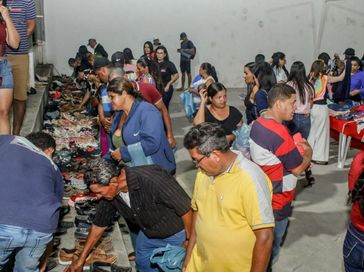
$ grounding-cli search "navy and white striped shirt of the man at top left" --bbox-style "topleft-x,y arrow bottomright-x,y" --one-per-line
7,0 -> 36,55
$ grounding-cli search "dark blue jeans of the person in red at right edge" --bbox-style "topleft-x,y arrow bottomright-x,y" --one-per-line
343,223 -> 364,272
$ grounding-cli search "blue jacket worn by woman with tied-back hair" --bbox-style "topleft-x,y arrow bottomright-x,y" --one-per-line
111,100 -> 176,172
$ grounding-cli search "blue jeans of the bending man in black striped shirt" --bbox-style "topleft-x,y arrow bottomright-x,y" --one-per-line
135,230 -> 186,272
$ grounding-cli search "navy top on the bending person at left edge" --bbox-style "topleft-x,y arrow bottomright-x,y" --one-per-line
0,135 -> 63,233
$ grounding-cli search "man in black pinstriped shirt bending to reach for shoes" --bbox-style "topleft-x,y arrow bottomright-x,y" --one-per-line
66,165 -> 192,272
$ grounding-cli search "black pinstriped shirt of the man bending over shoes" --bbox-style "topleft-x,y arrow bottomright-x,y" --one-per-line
93,165 -> 191,239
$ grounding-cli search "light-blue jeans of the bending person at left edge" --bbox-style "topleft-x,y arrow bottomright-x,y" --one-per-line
0,224 -> 52,272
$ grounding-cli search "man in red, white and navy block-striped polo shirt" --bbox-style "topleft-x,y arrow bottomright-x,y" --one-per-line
250,84 -> 312,270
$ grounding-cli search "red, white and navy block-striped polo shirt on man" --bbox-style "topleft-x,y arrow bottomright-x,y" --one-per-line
250,115 -> 303,221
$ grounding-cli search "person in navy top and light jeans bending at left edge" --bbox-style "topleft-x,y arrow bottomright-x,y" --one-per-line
0,132 -> 63,272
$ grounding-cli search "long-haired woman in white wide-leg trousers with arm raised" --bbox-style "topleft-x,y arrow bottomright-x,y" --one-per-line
308,60 -> 345,165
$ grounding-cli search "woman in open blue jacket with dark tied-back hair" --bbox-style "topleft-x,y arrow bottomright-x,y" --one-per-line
108,78 -> 176,174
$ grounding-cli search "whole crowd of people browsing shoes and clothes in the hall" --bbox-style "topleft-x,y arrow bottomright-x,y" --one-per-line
0,0 -> 364,272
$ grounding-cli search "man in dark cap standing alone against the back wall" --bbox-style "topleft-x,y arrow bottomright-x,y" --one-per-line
177,32 -> 196,90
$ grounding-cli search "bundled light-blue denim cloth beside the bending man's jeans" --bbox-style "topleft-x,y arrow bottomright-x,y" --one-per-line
150,244 -> 186,272
